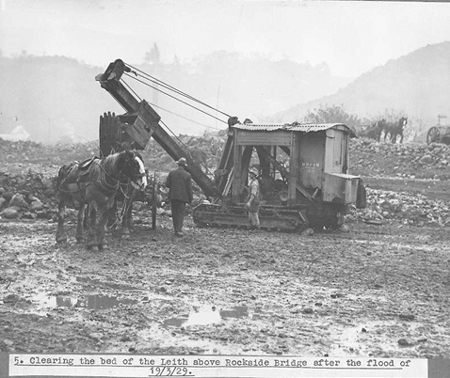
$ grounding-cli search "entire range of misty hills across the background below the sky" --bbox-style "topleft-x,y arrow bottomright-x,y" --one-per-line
5,42 -> 450,143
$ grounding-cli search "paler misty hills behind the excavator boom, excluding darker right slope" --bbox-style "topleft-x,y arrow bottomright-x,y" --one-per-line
0,52 -> 349,143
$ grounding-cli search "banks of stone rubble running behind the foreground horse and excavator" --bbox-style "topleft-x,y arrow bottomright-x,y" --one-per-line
0,136 -> 450,226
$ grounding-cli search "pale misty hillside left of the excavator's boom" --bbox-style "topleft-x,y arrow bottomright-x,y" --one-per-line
0,56 -> 121,142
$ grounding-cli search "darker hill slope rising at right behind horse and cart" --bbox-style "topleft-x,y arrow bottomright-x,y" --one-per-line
273,42 -> 450,140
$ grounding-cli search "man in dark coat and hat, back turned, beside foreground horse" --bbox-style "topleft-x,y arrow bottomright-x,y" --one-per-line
166,158 -> 192,237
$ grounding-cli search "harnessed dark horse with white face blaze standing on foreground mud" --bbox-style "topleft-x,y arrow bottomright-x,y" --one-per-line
56,150 -> 147,250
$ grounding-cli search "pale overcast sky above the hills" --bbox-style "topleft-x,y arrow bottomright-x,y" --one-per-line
0,0 -> 450,77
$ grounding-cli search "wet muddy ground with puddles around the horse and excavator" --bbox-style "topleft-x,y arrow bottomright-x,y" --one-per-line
0,140 -> 450,358
